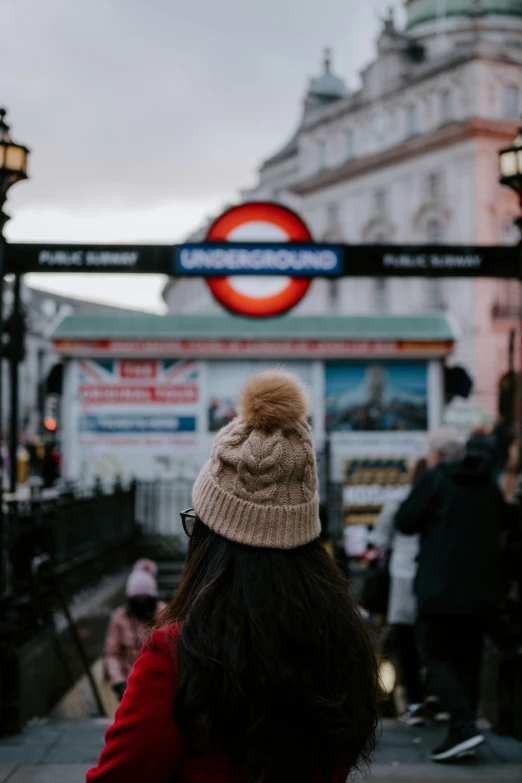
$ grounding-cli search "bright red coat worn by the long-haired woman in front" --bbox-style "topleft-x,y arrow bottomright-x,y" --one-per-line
87,626 -> 349,783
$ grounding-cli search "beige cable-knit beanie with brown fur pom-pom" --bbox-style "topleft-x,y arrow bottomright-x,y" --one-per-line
192,370 -> 321,549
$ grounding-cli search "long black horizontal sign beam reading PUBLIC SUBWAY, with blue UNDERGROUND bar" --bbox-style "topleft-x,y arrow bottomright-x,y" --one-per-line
5,242 -> 522,279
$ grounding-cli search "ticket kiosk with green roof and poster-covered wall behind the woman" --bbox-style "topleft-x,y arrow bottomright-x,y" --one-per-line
53,313 -> 455,544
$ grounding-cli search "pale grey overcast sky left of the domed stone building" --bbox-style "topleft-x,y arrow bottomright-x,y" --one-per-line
0,0 -> 402,309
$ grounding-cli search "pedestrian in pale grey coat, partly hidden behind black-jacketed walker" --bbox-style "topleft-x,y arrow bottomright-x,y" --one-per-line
373,458 -> 428,726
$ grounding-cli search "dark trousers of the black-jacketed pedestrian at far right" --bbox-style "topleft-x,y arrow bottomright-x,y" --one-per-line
418,614 -> 484,732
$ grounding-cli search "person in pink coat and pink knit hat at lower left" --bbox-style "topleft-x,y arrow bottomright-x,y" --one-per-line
104,560 -> 166,699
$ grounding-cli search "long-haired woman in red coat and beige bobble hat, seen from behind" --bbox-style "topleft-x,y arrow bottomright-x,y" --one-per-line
87,371 -> 378,783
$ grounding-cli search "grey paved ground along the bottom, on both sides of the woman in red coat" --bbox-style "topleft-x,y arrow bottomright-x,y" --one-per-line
0,718 -> 522,783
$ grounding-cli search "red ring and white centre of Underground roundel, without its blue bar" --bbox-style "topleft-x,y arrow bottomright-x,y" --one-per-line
206,202 -> 313,318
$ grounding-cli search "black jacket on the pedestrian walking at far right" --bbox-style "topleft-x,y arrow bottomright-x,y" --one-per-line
395,453 -> 510,615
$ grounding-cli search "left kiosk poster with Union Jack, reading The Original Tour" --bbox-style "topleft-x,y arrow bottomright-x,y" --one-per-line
70,359 -> 201,481
